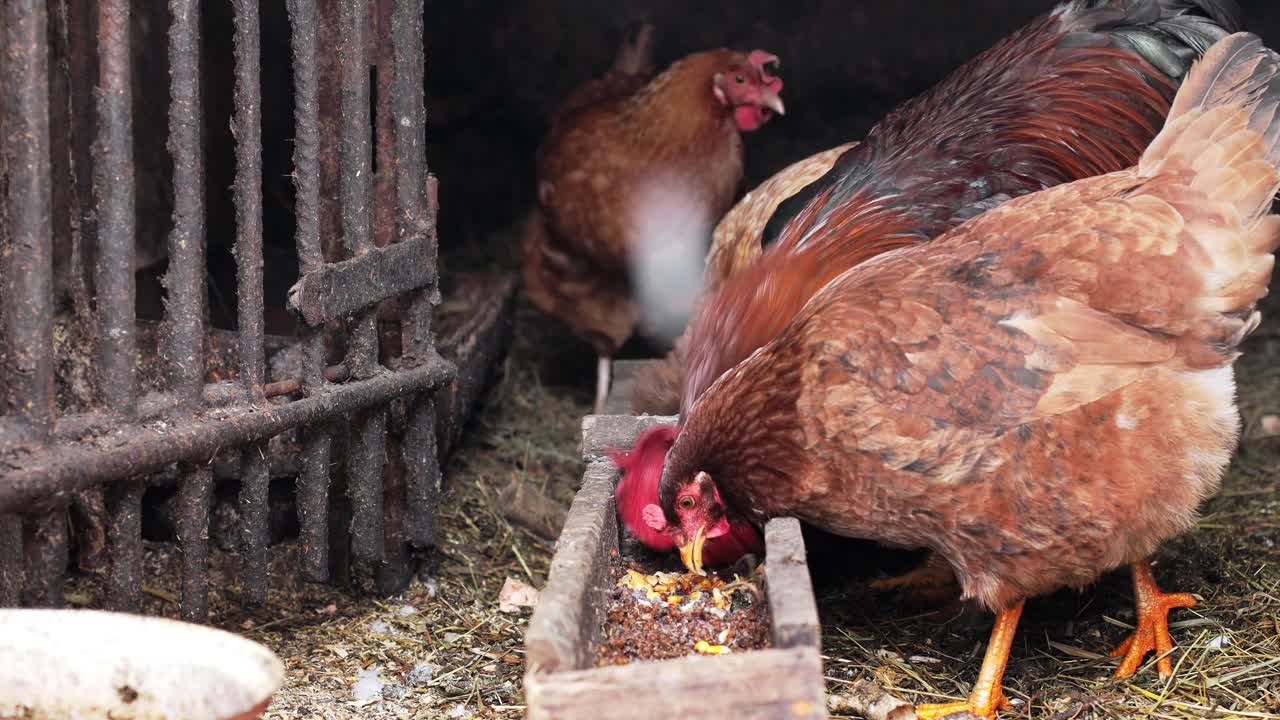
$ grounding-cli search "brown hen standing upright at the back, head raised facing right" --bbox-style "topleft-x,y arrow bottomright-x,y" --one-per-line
521,25 -> 783,413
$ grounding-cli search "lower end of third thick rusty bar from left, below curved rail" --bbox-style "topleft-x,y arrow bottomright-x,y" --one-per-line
178,462 -> 214,623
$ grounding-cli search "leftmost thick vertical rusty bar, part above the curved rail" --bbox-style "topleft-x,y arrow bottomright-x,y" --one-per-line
0,0 -> 55,441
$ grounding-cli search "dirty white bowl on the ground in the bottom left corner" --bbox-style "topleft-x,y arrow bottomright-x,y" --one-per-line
0,610 -> 284,720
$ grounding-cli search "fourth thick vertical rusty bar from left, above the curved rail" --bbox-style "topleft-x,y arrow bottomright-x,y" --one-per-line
232,0 -> 265,400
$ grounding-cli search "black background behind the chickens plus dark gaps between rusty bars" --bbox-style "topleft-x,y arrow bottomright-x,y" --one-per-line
115,0 -> 1280,334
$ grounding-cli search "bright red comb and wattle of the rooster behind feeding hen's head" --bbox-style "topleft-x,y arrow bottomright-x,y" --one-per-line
609,425 -> 764,566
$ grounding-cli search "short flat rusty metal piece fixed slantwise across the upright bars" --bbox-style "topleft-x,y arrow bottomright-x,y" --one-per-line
289,237 -> 435,325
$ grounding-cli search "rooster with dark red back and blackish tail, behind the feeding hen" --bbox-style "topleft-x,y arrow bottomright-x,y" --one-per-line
614,0 -> 1239,571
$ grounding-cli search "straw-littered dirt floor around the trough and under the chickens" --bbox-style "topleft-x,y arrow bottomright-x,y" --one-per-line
60,280 -> 1280,720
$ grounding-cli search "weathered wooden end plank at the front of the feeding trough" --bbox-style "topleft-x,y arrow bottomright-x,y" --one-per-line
525,648 -> 827,720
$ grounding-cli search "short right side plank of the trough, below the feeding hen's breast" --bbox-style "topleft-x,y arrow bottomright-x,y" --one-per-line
764,518 -> 822,650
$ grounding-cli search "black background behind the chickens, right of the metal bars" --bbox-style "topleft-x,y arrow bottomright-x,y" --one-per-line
426,0 -> 1280,256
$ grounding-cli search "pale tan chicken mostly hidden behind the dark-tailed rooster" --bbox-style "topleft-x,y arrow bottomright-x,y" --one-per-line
631,142 -> 858,415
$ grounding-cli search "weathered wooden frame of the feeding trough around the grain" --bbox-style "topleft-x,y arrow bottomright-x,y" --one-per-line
525,373 -> 827,720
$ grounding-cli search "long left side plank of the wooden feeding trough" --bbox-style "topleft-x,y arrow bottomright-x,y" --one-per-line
525,462 -> 618,673
